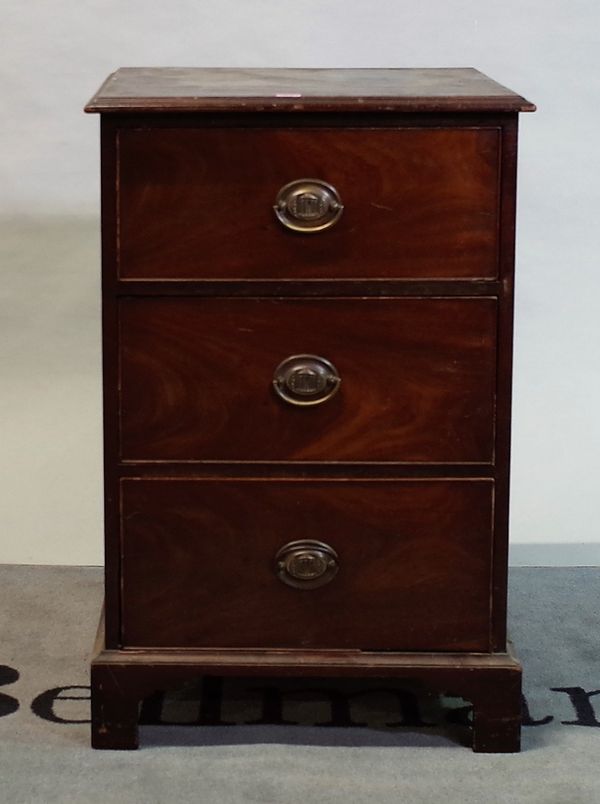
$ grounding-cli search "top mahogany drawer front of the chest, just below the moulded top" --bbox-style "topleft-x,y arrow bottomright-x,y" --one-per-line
118,127 -> 500,279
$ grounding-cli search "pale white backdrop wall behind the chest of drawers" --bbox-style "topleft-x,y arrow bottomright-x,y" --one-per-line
0,0 -> 600,564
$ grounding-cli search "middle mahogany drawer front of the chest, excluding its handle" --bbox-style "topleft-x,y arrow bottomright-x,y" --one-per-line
119,298 -> 496,463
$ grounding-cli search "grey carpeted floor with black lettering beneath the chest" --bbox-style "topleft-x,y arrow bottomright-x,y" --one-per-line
0,566 -> 600,804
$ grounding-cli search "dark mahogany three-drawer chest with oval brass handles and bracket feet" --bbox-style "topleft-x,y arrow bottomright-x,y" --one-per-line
86,69 -> 533,751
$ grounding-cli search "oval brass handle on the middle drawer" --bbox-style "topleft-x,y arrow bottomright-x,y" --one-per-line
273,355 -> 342,406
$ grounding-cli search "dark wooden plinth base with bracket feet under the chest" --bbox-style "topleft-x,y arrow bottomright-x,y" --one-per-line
91,612 -> 521,753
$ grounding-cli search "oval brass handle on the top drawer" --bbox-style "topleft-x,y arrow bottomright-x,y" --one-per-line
273,179 -> 344,233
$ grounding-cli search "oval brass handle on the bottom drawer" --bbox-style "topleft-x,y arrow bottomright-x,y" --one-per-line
275,539 -> 339,589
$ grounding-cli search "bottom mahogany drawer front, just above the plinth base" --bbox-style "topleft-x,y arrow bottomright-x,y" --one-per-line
121,479 -> 493,651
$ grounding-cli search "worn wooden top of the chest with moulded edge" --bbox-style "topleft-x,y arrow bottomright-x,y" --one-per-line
85,67 -> 535,112
